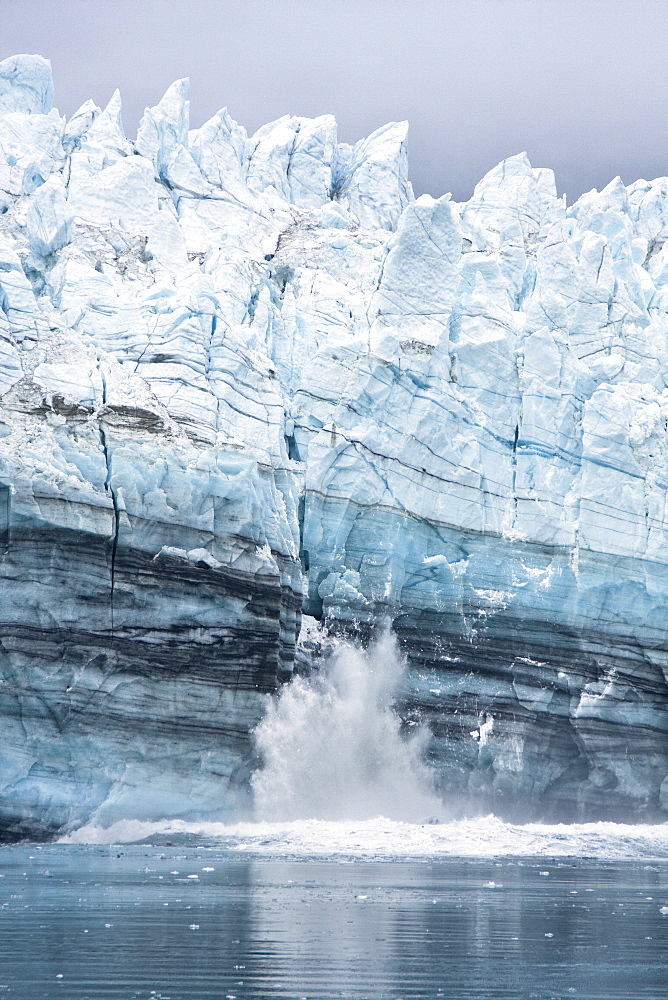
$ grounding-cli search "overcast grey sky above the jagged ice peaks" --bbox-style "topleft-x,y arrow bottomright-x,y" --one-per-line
0,0 -> 668,200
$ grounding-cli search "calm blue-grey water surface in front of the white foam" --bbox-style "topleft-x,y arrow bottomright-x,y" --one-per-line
0,843 -> 668,1000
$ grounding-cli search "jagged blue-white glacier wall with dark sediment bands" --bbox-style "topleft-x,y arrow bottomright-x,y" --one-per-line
0,55 -> 668,840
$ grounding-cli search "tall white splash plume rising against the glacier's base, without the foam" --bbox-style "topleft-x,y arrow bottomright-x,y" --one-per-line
252,632 -> 442,821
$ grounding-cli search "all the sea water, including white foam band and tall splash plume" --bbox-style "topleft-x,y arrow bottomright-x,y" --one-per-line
0,636 -> 668,1000
